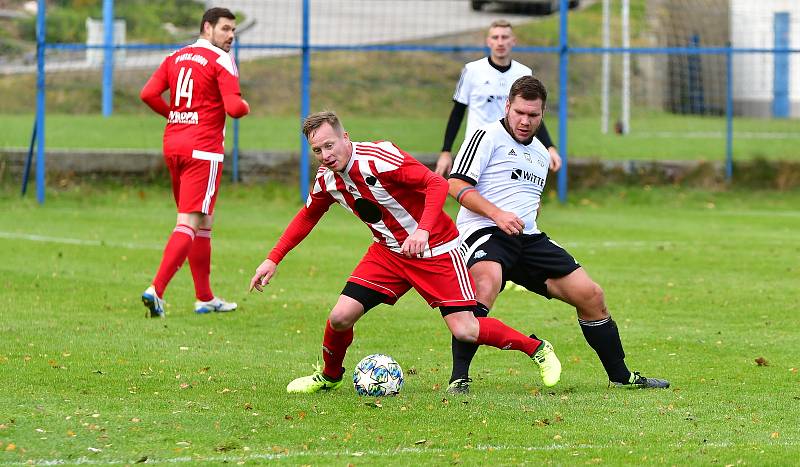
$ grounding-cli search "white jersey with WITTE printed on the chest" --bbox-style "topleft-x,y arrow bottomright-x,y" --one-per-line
450,120 -> 550,241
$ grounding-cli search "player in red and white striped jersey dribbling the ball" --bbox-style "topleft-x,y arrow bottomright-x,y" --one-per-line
250,112 -> 561,393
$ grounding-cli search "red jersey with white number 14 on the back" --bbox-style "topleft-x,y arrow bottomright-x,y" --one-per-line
148,39 -> 241,155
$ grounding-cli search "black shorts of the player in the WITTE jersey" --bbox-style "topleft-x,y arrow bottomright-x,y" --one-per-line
461,227 -> 581,298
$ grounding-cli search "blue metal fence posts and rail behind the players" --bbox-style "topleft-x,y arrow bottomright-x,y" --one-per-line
23,0 -> 800,203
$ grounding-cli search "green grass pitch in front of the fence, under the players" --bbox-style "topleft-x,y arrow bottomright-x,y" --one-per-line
0,185 -> 800,465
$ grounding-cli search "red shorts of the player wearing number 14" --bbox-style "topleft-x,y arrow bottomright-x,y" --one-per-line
164,151 -> 223,214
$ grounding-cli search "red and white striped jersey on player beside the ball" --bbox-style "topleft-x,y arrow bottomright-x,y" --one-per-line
269,141 -> 458,263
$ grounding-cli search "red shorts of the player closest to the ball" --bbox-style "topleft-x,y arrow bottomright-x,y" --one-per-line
348,243 -> 476,308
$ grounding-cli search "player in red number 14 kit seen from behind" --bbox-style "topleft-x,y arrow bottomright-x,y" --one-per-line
140,8 -> 250,317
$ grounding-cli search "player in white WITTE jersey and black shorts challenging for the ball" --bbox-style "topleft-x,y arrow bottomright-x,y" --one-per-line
448,76 -> 669,394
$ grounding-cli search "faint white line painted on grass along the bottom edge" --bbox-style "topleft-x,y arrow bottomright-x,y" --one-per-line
6,440 -> 800,465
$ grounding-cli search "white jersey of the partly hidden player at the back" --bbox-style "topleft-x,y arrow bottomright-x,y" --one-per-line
453,57 -> 533,138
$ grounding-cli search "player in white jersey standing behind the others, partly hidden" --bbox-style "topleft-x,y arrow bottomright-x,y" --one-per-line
436,20 -> 561,177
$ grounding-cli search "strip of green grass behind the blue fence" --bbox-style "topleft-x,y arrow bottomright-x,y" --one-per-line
0,113 -> 800,161
